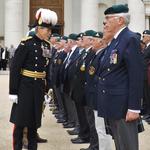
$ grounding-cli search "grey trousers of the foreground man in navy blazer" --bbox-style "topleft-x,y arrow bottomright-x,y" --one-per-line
109,119 -> 139,150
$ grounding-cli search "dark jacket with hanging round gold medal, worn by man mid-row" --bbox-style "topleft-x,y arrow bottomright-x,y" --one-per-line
68,50 -> 95,105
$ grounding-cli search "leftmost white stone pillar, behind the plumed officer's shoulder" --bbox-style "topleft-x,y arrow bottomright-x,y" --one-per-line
4,0 -> 23,47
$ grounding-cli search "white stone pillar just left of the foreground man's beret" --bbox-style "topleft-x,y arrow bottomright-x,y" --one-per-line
81,0 -> 101,32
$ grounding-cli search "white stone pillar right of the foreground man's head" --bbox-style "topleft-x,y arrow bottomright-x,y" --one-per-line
128,0 -> 145,33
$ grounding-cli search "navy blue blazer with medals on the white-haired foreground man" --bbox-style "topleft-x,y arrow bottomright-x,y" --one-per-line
97,28 -> 144,119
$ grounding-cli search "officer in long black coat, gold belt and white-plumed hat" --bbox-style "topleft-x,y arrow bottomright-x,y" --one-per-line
9,9 -> 57,150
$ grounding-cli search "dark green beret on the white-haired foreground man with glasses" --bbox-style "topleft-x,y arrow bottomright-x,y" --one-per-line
104,4 -> 129,15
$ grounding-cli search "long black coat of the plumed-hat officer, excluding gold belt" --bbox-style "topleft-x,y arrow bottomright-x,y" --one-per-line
9,35 -> 50,128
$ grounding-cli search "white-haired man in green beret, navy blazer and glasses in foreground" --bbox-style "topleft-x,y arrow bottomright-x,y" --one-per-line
97,5 -> 143,150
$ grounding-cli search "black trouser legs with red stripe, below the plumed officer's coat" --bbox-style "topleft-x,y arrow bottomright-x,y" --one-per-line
13,125 -> 37,150
